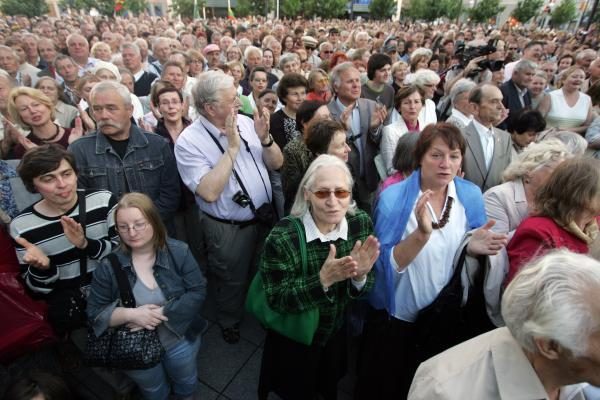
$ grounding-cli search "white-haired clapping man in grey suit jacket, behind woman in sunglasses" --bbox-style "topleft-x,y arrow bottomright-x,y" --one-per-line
327,62 -> 387,212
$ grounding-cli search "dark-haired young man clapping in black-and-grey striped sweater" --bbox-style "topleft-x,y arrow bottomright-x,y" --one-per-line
10,144 -> 118,334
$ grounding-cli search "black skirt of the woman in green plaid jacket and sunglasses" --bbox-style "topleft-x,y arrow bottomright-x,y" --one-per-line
258,329 -> 347,400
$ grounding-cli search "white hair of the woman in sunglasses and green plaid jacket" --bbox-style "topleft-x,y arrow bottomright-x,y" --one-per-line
290,154 -> 356,218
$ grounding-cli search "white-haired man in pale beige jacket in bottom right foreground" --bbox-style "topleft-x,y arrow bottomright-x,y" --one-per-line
408,251 -> 600,400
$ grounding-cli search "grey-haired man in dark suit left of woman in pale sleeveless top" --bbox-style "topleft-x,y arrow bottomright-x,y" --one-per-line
498,60 -> 537,129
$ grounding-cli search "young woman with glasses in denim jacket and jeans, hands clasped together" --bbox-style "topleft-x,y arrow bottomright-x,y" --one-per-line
87,193 -> 206,400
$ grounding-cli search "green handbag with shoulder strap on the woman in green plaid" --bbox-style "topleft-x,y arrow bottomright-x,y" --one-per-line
246,217 -> 319,346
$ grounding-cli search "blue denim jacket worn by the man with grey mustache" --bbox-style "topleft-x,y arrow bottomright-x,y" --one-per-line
69,124 -> 180,221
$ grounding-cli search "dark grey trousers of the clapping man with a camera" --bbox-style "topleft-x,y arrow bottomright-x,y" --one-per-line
202,215 -> 267,328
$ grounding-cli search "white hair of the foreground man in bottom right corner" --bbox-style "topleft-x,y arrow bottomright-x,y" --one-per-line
502,250 -> 600,357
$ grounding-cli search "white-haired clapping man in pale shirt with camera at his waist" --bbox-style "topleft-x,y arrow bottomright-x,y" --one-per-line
175,71 -> 283,343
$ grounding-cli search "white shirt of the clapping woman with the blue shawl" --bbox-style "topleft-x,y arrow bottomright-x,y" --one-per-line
390,181 -> 468,322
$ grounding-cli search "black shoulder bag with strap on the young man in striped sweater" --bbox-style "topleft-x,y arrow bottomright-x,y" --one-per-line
45,190 -> 90,337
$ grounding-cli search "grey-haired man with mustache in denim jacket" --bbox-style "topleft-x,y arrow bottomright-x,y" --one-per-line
69,81 -> 180,234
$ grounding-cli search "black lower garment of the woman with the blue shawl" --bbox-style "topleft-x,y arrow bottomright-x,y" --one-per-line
354,309 -> 419,400
